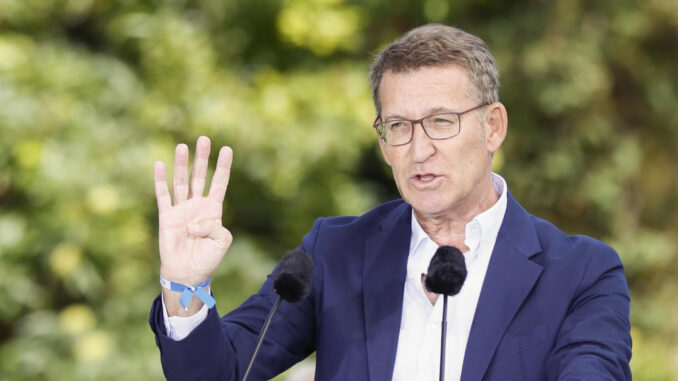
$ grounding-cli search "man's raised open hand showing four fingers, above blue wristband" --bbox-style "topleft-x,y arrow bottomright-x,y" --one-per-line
154,136 -> 233,286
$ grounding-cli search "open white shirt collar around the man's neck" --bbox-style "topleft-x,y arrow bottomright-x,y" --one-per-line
410,172 -> 507,258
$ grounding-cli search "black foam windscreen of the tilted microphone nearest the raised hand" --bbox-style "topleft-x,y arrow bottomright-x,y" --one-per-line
273,249 -> 313,303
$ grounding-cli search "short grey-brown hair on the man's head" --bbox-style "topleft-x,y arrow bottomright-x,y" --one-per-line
370,24 -> 499,114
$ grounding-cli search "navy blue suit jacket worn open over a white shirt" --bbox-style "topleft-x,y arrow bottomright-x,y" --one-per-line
150,193 -> 631,381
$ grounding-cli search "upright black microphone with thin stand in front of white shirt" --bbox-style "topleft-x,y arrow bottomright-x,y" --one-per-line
424,246 -> 467,381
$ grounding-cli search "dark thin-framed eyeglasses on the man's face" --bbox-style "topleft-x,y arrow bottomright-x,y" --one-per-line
372,103 -> 489,146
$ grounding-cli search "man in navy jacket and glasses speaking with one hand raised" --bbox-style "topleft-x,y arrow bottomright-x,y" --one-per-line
150,25 -> 631,381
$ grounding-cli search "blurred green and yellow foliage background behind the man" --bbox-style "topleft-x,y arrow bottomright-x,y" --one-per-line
0,0 -> 678,380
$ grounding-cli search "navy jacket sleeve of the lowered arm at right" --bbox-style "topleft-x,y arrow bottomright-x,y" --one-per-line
548,240 -> 631,380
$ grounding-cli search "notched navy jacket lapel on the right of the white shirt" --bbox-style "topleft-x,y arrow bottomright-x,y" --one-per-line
461,192 -> 543,381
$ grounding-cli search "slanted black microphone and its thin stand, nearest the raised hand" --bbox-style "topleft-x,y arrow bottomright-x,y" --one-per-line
242,249 -> 313,381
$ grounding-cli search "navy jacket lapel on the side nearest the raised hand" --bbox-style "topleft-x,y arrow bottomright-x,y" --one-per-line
363,203 -> 412,381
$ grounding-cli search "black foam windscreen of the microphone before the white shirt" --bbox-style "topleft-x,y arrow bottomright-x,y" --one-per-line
425,246 -> 466,296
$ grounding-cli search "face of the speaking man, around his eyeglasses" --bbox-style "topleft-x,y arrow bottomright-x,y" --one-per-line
380,65 -> 503,218
